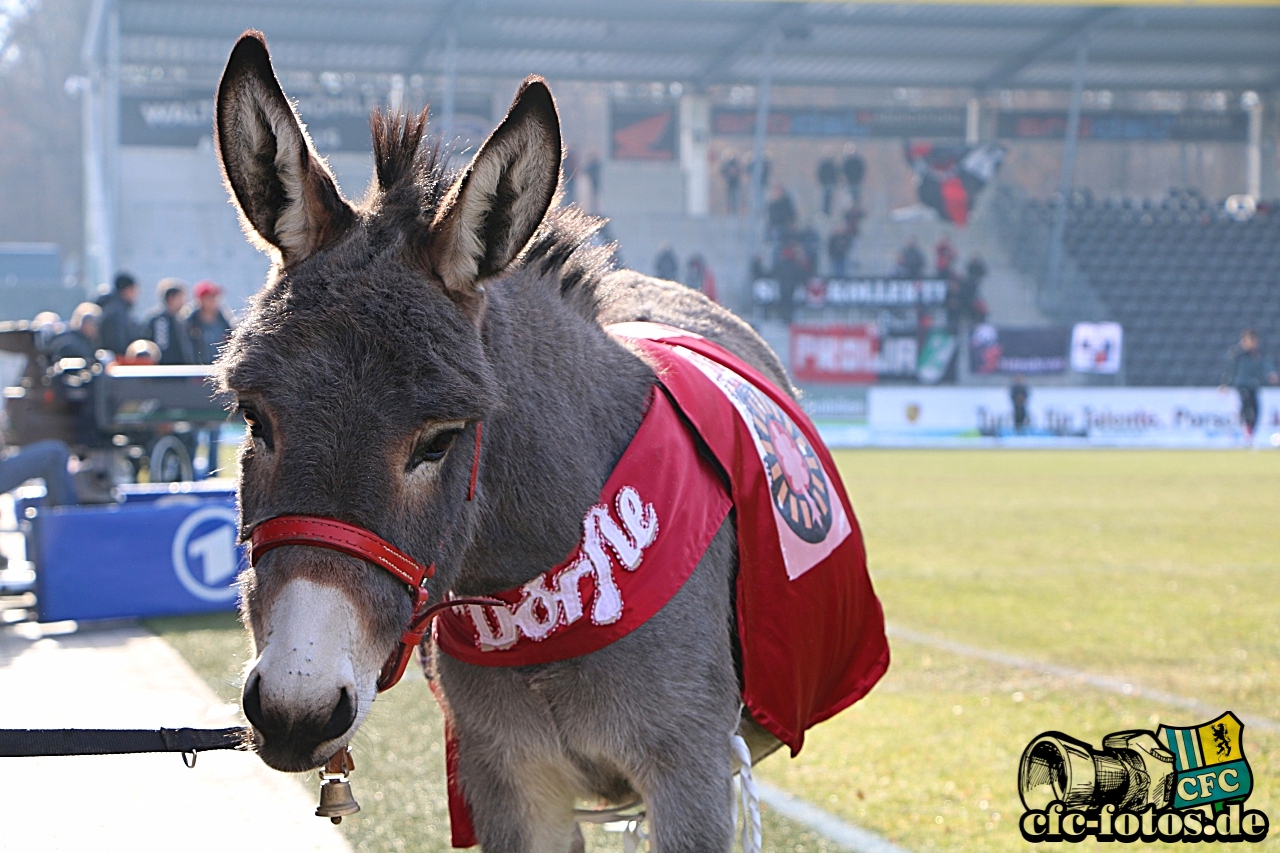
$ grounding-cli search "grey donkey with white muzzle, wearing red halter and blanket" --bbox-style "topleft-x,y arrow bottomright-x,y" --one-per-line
216,32 -> 790,853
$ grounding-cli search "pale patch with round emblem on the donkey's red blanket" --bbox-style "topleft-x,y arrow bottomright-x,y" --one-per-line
672,346 -> 850,580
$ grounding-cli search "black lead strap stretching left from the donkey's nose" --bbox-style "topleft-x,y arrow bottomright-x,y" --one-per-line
0,726 -> 250,767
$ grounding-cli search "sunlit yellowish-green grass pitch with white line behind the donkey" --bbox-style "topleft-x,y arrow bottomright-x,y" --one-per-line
145,451 -> 1280,853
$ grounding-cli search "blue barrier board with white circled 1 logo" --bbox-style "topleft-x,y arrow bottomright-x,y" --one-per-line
35,494 -> 248,621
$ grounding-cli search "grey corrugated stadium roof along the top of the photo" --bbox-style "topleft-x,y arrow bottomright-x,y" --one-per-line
108,0 -> 1280,91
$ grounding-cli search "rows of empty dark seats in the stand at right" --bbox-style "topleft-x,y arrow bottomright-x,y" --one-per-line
1000,188 -> 1280,386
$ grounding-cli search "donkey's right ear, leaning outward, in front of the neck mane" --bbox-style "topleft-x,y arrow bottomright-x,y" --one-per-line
426,77 -> 561,309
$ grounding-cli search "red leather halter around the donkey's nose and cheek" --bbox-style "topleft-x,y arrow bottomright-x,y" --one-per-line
248,423 -> 495,693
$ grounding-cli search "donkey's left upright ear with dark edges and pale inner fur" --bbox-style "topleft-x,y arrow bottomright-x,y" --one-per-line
214,31 -> 355,266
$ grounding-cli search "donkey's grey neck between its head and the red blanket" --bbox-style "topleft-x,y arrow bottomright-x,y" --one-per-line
454,272 -> 654,594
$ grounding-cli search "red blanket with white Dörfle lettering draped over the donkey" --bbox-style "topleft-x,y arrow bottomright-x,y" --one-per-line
435,323 -> 888,847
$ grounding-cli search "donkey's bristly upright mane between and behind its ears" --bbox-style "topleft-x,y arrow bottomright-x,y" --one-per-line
370,108 -> 616,321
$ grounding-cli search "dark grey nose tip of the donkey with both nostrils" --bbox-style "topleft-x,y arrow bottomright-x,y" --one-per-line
243,672 -> 357,771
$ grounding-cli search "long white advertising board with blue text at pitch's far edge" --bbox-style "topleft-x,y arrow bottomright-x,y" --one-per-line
819,386 -> 1280,447
